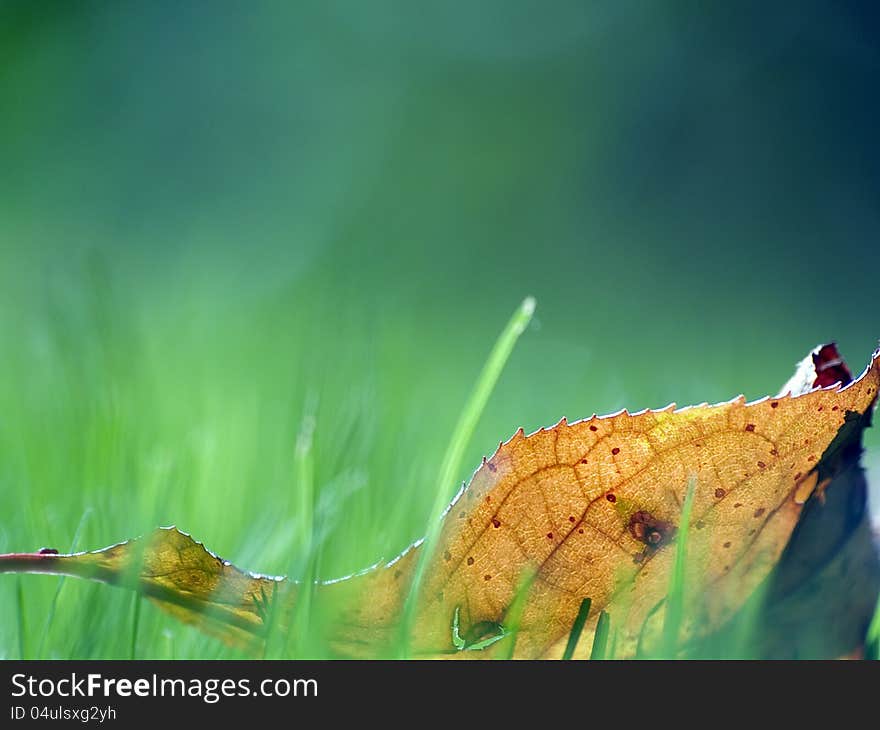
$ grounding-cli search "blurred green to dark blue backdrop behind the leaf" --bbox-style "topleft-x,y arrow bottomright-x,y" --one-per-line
0,0 -> 880,658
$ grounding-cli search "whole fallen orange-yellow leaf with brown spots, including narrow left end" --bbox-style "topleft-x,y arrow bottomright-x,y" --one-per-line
0,344 -> 880,658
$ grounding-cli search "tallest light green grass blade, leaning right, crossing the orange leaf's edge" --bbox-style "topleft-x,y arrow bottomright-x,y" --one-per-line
399,297 -> 535,657
